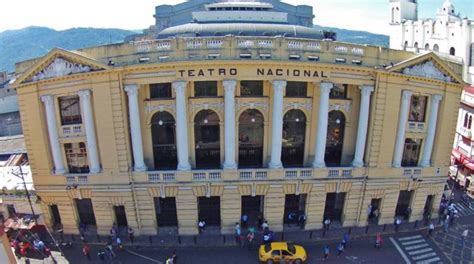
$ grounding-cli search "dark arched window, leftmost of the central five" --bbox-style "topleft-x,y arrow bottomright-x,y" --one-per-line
151,112 -> 178,170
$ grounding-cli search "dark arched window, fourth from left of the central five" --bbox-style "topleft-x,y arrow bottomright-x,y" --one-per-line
281,109 -> 306,167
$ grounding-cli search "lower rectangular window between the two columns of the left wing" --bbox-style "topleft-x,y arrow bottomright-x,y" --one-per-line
64,142 -> 89,173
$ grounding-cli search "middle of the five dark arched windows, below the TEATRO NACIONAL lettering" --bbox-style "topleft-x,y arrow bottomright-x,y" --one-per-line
239,109 -> 264,168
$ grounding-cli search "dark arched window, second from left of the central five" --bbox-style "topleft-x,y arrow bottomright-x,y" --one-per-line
194,110 -> 221,169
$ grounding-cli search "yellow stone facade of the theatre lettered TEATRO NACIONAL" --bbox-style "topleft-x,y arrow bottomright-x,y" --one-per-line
15,37 -> 463,234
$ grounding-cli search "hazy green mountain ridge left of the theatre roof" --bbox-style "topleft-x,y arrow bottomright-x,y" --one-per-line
0,27 -> 136,72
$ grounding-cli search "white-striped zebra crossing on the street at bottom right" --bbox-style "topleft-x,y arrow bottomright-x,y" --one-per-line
394,235 -> 441,264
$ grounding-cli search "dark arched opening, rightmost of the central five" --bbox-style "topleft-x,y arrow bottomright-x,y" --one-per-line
324,111 -> 346,167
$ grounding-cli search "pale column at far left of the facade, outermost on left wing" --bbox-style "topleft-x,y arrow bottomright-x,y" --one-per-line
41,95 -> 66,174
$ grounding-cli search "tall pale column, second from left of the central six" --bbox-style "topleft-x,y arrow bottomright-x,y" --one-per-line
173,81 -> 191,170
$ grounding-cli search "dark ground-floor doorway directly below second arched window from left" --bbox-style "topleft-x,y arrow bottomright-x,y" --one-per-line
198,196 -> 221,227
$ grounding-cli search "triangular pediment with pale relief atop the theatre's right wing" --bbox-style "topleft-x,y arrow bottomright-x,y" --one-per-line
387,53 -> 464,84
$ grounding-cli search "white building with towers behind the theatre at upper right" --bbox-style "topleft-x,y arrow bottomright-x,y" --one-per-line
390,0 -> 474,84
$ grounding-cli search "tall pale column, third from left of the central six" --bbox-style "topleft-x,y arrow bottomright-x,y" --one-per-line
223,80 -> 237,170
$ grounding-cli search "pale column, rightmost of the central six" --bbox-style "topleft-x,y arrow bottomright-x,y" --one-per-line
352,85 -> 374,167
